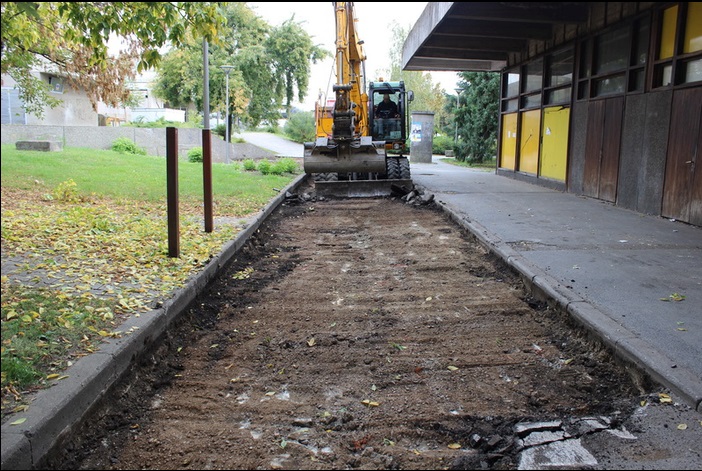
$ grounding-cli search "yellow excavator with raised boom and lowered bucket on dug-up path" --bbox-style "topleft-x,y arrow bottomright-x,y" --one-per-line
303,2 -> 414,197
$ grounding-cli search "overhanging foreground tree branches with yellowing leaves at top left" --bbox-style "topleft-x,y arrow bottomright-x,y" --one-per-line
0,2 -> 224,117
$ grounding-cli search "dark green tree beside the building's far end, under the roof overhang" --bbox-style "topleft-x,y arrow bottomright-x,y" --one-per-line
454,72 -> 500,163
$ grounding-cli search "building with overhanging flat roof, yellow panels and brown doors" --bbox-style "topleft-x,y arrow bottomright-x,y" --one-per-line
403,2 -> 702,226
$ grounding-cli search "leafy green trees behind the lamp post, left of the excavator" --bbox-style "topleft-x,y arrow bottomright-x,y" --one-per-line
154,2 -> 330,126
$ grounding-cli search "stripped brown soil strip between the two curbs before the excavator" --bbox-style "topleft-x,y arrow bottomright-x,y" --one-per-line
50,183 -> 672,469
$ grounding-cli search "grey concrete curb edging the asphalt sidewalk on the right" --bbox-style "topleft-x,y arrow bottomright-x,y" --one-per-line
426,192 -> 702,412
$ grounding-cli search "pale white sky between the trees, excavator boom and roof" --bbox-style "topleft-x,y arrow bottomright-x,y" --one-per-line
247,2 -> 457,111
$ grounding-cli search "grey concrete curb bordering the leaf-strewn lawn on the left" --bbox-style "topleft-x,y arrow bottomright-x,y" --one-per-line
0,174 -> 307,470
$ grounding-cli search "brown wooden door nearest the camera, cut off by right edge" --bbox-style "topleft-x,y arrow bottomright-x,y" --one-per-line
661,87 -> 702,226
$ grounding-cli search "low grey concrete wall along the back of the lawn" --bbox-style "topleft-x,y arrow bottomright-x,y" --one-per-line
0,124 -> 275,162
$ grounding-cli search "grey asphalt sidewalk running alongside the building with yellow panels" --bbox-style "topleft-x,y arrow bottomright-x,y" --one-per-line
411,156 -> 702,412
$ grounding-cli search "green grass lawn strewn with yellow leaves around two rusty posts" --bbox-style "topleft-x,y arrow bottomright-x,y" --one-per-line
0,145 -> 301,417
